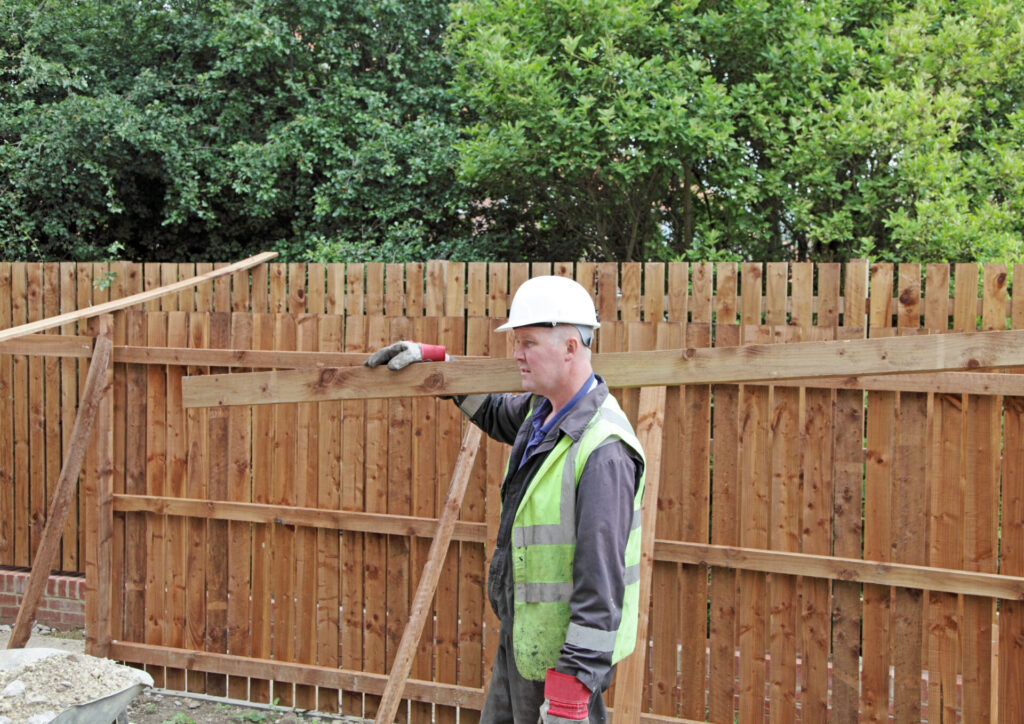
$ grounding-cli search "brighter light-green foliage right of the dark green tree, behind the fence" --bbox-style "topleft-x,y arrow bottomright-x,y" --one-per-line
451,0 -> 1024,260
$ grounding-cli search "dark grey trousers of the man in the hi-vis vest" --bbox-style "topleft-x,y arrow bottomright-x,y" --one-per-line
480,625 -> 614,724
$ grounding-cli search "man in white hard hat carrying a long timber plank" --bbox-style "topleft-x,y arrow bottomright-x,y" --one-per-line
366,276 -> 644,724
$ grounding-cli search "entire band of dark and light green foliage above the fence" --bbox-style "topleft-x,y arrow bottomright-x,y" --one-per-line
0,0 -> 1024,261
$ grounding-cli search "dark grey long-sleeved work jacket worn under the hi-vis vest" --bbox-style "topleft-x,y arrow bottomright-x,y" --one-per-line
457,378 -> 643,691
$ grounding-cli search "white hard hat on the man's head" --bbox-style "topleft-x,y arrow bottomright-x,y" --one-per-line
498,276 -> 601,332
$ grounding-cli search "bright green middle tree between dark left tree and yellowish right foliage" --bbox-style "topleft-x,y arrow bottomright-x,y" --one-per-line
450,0 -> 737,259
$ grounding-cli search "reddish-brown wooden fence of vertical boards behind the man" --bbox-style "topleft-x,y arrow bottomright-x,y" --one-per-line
0,262 -> 1024,722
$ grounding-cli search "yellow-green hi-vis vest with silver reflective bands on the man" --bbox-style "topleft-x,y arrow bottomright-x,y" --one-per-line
512,394 -> 646,681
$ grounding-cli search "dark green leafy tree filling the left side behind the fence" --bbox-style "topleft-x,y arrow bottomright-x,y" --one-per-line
0,0 -> 465,260
